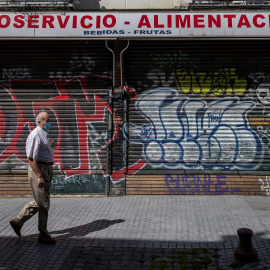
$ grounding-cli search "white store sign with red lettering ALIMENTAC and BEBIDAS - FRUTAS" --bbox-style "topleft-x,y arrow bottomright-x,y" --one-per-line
0,12 -> 270,38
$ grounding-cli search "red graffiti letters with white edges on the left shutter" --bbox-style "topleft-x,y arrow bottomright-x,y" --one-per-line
0,74 -> 111,176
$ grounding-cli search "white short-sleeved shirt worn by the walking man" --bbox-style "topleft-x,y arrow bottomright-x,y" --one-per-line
26,126 -> 54,162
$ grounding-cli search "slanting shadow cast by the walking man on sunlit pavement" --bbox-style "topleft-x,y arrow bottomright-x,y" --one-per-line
50,219 -> 125,239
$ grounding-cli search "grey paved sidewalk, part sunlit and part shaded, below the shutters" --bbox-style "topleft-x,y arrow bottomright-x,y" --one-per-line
0,195 -> 270,270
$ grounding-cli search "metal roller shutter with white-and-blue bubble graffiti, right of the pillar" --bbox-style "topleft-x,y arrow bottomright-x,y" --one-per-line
124,40 -> 270,195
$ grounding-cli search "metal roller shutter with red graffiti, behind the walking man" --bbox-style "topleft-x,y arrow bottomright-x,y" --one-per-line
0,40 -> 112,195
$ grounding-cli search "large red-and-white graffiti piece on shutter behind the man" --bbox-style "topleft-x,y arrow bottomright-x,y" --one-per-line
0,73 -> 108,176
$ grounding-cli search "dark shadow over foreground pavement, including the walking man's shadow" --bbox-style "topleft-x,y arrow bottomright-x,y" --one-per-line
0,219 -> 270,270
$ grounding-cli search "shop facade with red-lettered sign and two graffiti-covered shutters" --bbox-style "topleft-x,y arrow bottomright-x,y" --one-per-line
0,0 -> 270,196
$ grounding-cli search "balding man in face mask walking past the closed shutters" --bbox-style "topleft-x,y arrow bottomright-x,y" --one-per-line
10,112 -> 55,244
